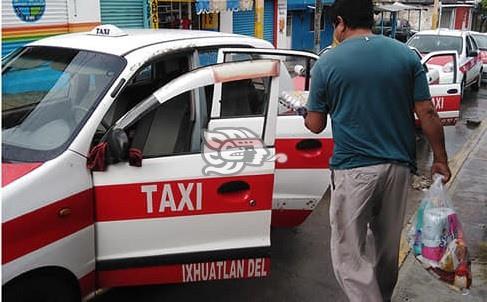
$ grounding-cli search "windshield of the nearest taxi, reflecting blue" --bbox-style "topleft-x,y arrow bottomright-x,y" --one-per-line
2,46 -> 125,162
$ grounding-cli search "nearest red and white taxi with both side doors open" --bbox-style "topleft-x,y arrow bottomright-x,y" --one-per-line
2,25 -> 333,301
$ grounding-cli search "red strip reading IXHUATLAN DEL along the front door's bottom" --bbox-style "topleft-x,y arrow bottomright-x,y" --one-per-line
98,258 -> 271,288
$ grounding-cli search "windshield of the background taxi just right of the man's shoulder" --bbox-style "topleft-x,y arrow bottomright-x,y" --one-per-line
407,35 -> 463,54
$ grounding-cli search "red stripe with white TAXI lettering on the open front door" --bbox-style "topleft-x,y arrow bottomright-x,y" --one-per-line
95,174 -> 274,221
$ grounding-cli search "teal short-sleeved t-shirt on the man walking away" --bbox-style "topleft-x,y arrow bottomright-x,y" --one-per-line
307,35 -> 431,171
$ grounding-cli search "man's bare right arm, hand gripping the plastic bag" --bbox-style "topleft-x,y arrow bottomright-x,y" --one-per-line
414,100 -> 451,183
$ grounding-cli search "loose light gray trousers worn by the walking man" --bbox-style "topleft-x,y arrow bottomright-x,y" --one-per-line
330,164 -> 410,302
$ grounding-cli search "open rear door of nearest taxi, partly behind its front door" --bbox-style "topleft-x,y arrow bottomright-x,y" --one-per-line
213,48 -> 333,227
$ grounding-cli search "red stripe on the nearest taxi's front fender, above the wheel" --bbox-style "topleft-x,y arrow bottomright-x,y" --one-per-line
2,190 -> 93,264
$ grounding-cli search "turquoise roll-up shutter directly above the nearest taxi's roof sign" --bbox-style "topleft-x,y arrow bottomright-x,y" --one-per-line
100,0 -> 144,28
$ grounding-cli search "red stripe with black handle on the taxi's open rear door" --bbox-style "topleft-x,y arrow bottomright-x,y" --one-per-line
276,138 -> 333,169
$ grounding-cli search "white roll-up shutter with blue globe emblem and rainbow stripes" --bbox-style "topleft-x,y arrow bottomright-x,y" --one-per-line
2,0 -> 69,56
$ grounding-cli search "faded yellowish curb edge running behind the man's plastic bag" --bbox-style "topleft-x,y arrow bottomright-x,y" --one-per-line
398,118 -> 487,268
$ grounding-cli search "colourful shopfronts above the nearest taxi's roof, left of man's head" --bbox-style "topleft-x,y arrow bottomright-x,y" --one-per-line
2,0 -> 334,56
